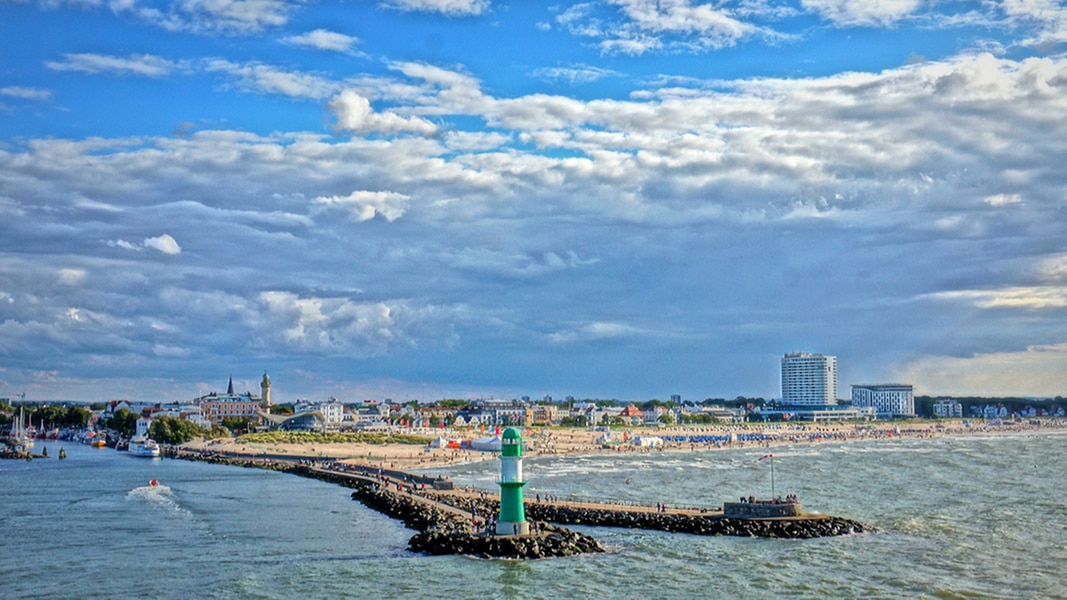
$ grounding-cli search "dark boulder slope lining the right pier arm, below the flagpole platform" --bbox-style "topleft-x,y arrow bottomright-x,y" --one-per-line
428,494 -> 877,539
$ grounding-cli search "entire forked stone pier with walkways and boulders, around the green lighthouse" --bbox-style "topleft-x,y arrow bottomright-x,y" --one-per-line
168,447 -> 877,559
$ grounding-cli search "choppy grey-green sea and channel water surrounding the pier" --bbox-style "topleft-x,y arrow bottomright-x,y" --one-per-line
0,432 -> 1067,599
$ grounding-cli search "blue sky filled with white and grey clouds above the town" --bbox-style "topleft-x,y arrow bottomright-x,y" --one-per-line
0,0 -> 1067,401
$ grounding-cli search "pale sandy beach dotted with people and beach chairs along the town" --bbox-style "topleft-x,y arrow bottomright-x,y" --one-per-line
184,420 -> 1067,470
